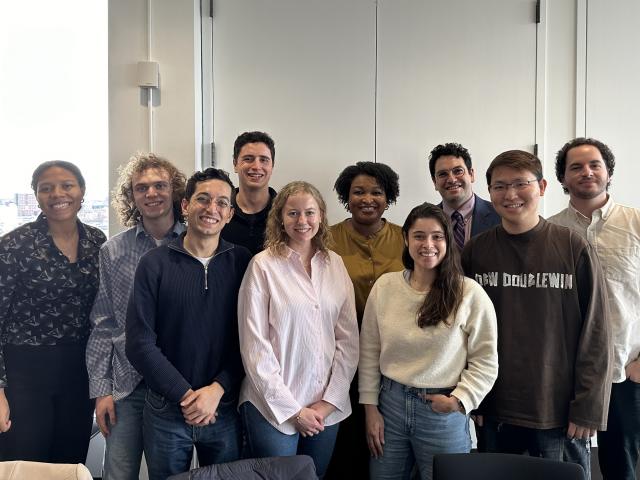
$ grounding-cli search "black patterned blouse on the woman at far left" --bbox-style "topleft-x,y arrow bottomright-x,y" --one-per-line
0,214 -> 106,387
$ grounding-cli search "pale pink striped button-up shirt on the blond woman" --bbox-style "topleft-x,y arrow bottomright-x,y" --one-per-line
238,247 -> 358,434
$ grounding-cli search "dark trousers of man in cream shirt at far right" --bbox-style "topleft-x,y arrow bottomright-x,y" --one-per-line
598,380 -> 640,480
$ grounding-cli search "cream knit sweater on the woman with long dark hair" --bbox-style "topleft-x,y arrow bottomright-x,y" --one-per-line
358,272 -> 498,412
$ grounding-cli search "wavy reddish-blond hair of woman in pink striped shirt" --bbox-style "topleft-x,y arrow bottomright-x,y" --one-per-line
264,181 -> 332,255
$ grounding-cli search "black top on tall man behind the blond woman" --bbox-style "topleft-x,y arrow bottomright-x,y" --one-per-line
221,187 -> 276,255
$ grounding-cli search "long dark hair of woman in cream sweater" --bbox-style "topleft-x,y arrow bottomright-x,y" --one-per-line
402,202 -> 463,328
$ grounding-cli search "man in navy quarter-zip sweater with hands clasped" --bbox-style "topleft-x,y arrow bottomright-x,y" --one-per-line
126,168 -> 251,480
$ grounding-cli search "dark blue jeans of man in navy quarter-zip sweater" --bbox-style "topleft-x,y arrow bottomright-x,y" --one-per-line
143,390 -> 242,480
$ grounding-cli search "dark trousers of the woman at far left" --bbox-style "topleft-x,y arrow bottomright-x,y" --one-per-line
0,345 -> 94,463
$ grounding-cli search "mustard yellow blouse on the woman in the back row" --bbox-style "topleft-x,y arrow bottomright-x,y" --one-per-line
331,219 -> 404,325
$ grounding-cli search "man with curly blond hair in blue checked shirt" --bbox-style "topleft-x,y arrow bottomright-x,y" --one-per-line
86,153 -> 185,480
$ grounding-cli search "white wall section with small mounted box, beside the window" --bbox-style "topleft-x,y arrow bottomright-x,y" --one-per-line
109,0 -> 201,234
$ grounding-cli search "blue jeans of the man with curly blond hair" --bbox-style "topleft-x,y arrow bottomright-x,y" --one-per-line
102,382 -> 147,480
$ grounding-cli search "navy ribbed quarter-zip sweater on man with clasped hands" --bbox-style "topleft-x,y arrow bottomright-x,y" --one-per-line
125,233 -> 251,403
